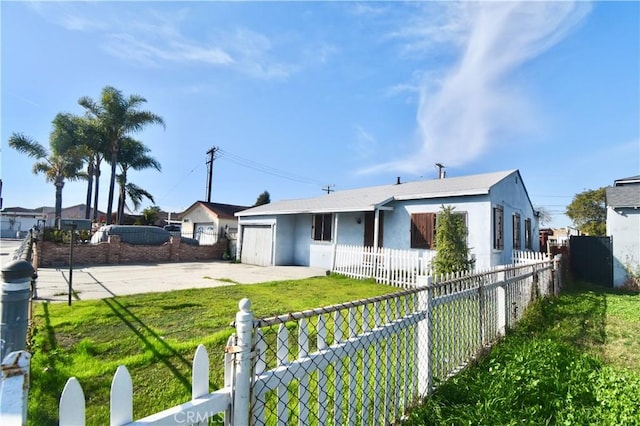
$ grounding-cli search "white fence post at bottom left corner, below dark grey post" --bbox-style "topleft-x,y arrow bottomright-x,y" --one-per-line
0,351 -> 31,426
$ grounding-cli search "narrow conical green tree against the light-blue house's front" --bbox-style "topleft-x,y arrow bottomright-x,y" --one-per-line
433,205 -> 474,275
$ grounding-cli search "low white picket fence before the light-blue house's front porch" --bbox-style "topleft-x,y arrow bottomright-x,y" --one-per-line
332,244 -> 436,288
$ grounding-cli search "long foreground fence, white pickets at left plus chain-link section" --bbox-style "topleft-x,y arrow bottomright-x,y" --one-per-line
51,257 -> 561,426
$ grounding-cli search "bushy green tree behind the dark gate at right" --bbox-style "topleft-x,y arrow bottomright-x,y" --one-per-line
566,188 -> 607,236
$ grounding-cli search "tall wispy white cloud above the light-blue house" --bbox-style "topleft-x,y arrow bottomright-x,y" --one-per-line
365,1 -> 590,174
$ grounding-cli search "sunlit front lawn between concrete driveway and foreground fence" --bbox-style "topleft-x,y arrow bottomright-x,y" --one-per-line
28,275 -> 397,426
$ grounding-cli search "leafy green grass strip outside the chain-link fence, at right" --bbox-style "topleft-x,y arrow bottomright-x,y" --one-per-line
405,283 -> 640,425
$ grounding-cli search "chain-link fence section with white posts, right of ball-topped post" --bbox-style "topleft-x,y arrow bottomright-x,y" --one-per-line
244,261 -> 553,425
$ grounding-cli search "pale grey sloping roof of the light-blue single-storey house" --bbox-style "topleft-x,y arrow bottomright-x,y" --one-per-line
236,170 -> 519,216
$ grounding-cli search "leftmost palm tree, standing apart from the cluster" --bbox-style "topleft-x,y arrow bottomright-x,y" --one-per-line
8,125 -> 85,226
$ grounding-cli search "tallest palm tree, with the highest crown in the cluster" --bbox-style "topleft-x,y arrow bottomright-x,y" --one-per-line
78,86 -> 164,224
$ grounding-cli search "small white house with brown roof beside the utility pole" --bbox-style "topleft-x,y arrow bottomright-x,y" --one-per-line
180,201 -> 248,245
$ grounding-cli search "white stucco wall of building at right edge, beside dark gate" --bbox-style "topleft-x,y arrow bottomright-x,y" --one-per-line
607,207 -> 640,287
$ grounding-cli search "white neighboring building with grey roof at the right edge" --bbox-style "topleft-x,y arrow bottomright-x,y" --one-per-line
606,175 -> 640,287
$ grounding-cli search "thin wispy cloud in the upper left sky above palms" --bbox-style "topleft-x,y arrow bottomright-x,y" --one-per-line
32,2 -> 298,80
